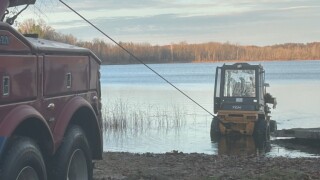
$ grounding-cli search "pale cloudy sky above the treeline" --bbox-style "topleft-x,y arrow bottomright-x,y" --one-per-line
14,0 -> 320,46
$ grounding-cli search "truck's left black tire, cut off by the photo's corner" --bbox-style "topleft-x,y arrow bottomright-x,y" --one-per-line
0,137 -> 47,180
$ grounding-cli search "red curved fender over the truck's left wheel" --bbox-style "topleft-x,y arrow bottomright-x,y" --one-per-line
0,105 -> 54,154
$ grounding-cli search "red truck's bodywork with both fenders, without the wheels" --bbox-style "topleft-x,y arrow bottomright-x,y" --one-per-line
0,23 -> 102,159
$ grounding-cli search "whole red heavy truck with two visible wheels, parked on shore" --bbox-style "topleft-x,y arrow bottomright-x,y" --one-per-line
0,0 -> 103,180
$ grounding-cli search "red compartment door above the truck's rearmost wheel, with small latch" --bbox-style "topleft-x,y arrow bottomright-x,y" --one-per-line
44,55 -> 90,96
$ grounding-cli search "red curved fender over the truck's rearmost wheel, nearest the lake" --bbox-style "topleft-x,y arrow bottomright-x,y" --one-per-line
53,96 -> 99,151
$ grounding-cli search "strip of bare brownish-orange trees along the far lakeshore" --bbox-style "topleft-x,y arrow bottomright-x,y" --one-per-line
18,19 -> 320,64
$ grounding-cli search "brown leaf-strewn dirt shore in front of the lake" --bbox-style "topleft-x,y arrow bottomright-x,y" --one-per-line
94,152 -> 320,180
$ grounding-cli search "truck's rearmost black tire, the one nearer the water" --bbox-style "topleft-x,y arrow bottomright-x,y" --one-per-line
48,125 -> 93,180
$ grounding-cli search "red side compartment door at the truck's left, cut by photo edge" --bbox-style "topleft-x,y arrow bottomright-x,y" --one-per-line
0,55 -> 38,104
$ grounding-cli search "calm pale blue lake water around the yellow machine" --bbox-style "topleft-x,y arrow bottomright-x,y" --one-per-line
101,61 -> 320,157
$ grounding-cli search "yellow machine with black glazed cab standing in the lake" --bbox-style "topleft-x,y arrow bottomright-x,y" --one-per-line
211,63 -> 276,137
